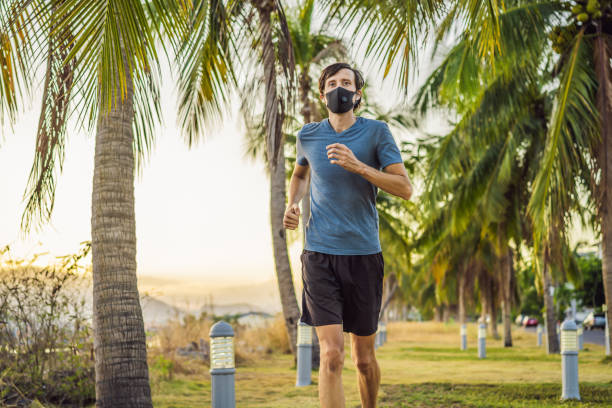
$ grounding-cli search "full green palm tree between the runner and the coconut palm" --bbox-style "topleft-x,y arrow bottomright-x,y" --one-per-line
404,4 -> 560,346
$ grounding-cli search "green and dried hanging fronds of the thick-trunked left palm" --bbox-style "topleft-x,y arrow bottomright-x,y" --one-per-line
22,0 -> 184,232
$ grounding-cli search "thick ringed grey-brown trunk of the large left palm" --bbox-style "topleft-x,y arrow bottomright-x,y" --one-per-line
91,67 -> 153,408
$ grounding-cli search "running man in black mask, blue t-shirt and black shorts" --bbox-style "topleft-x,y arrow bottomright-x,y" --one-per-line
283,63 -> 412,408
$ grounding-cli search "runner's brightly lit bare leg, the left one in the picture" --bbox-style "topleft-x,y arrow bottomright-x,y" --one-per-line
315,324 -> 344,408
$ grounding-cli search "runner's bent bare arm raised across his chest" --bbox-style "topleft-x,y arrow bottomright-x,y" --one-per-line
327,143 -> 412,200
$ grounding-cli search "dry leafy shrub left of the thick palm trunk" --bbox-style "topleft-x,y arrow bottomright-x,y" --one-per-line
0,244 -> 95,406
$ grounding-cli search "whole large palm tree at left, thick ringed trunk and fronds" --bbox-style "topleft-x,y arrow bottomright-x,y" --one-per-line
15,0 -> 194,407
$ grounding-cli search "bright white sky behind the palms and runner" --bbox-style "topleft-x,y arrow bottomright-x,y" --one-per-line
0,22 -> 416,284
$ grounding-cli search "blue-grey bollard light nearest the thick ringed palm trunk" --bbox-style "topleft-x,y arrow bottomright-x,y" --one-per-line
210,321 -> 236,408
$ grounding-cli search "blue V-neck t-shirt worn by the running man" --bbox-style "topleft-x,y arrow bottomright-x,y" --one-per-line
297,116 -> 403,255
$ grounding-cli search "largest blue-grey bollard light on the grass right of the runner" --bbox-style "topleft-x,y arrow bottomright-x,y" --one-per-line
561,319 -> 580,400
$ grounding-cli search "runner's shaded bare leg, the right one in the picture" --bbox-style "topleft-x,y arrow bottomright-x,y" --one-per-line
351,333 -> 380,408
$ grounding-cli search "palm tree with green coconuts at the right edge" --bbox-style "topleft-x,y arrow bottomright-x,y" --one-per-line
529,1 -> 612,352
